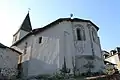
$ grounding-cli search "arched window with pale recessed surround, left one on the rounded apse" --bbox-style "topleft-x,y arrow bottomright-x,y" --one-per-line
76,25 -> 86,41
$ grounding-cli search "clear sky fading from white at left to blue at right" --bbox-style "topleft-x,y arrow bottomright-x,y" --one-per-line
0,0 -> 120,50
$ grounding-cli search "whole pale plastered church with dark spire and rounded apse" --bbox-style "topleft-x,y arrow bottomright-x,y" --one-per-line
11,13 -> 104,77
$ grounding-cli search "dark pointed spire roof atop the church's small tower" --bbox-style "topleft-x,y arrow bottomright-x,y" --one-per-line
20,12 -> 32,32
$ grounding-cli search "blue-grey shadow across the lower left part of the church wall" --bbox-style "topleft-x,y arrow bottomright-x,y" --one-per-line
19,58 -> 57,77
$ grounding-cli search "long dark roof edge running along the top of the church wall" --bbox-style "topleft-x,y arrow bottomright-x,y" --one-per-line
12,18 -> 99,46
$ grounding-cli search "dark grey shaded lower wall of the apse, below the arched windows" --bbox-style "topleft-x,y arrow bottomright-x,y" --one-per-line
76,55 -> 104,73
